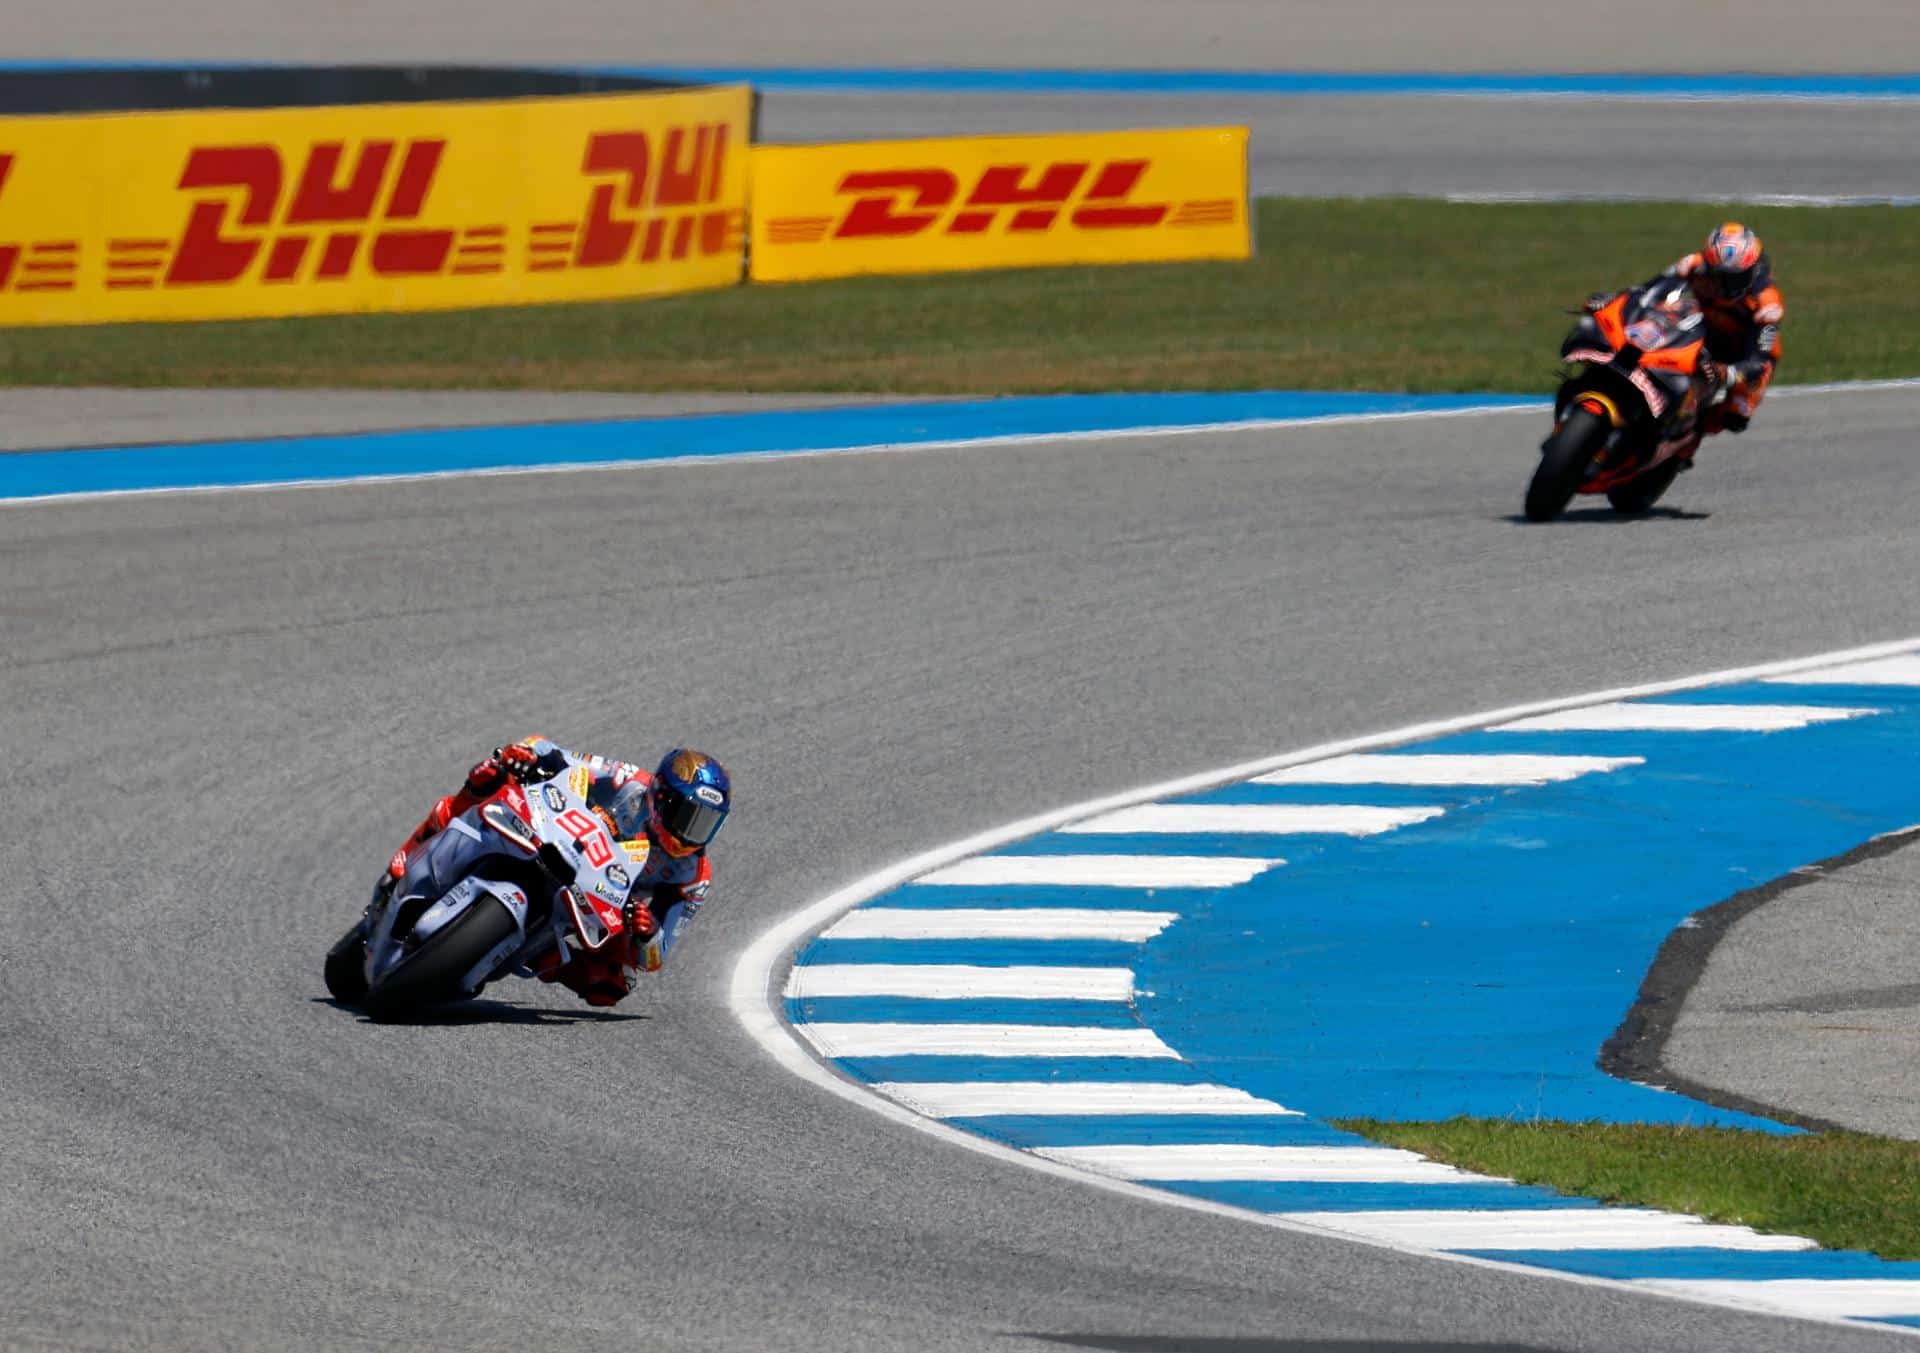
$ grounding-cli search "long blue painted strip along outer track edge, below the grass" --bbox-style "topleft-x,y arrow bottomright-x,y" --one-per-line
0,390 -> 1540,501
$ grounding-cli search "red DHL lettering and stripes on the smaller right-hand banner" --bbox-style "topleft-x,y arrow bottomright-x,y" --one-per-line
768,159 -> 1238,244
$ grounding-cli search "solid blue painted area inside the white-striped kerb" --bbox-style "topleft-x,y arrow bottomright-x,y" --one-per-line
1128,685 -> 1920,1127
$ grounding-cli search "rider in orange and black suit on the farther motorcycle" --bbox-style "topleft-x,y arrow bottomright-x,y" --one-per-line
1586,221 -> 1786,434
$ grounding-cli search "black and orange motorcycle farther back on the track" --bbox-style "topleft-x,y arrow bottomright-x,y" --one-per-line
1526,278 -> 1726,522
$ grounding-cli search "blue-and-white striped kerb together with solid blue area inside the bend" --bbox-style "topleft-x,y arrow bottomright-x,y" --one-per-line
785,654 -> 1920,1318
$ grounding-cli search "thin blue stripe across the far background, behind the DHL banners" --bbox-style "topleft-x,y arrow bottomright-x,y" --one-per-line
593,65 -> 1920,102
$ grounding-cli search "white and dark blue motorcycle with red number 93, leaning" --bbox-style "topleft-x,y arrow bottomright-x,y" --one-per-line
324,771 -> 660,1019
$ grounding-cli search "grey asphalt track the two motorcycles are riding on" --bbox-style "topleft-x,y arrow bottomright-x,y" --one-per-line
0,390 -> 1920,1353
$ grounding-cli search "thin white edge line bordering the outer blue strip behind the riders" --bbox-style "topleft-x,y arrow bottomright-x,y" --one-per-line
0,376 -> 1920,509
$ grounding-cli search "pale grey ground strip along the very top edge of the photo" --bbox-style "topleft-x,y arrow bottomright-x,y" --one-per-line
15,0 -> 1914,73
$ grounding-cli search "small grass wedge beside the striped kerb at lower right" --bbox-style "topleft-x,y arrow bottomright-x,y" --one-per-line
1338,1119 -> 1920,1259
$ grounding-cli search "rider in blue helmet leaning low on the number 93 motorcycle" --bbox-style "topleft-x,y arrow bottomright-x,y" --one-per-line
376,733 -> 733,1006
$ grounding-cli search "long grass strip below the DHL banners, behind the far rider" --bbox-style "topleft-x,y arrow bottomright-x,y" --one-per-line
15,198 -> 1920,393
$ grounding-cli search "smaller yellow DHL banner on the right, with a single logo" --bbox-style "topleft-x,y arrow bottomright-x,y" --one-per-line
751,127 -> 1254,282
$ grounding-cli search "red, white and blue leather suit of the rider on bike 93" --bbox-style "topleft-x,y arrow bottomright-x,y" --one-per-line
386,733 -> 712,1006
